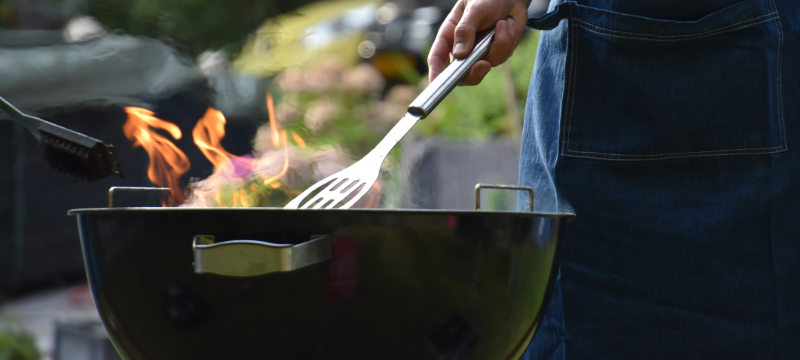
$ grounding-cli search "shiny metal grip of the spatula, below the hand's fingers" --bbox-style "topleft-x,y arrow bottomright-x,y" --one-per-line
408,28 -> 494,119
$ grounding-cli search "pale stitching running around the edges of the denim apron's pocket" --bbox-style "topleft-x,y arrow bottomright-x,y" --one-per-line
562,0 -> 788,161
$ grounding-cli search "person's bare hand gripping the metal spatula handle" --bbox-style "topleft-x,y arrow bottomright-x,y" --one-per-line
428,0 -> 531,85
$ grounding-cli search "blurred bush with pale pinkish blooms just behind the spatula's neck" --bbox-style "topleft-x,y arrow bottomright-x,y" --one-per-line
273,59 -> 400,158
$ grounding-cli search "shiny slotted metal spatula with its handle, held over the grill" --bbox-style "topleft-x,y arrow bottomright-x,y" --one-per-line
283,29 -> 494,209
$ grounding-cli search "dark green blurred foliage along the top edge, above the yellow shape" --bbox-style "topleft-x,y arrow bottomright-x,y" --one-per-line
86,0 -> 313,54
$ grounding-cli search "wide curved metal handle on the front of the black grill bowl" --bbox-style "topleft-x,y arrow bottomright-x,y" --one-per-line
192,235 -> 333,277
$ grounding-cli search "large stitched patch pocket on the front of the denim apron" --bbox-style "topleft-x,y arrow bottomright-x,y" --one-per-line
531,0 -> 786,161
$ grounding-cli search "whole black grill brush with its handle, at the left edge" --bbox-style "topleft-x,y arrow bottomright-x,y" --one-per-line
0,97 -> 124,181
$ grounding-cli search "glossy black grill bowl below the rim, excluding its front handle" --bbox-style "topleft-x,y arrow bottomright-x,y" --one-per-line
70,208 -> 572,360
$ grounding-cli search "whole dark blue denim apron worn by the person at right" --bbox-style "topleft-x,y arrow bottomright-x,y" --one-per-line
518,0 -> 800,360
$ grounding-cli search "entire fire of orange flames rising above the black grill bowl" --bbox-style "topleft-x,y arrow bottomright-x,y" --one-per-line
131,93 -> 381,208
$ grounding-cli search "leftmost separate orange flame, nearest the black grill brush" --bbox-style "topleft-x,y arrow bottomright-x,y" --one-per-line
122,107 -> 191,206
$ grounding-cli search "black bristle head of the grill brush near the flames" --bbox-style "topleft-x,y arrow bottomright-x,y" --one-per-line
39,131 -> 122,182
